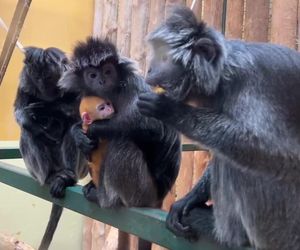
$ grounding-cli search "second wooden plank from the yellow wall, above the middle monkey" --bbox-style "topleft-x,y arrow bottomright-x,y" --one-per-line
102,0 -> 118,44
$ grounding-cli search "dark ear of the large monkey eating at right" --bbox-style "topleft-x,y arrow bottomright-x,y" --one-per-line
193,38 -> 217,62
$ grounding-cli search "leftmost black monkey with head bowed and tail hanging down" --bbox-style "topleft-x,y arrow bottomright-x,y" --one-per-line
14,47 -> 88,250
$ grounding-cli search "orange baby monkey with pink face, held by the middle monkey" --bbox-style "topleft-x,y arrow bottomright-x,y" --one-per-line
79,96 -> 114,187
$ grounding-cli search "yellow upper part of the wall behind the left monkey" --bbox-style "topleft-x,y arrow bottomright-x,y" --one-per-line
0,0 -> 94,140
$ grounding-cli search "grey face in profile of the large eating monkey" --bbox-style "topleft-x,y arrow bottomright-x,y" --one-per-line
146,44 -> 190,99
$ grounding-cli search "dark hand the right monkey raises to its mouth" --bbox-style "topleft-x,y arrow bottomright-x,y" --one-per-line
137,93 -> 179,121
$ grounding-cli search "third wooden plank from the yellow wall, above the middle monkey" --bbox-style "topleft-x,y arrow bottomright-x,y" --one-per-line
117,0 -> 132,57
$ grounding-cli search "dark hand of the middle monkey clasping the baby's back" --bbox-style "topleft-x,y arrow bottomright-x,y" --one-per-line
71,122 -> 99,155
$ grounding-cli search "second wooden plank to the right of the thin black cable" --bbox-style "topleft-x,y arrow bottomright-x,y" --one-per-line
244,0 -> 270,42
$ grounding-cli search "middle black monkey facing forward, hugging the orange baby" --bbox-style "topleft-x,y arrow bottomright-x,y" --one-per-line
59,38 -> 181,249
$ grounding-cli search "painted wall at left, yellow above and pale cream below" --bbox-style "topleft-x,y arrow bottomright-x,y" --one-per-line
0,0 -> 94,250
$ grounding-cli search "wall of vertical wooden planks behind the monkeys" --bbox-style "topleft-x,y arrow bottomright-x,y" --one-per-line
84,0 -> 300,250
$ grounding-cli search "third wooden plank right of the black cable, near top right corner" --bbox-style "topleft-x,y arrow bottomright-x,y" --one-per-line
270,0 -> 298,48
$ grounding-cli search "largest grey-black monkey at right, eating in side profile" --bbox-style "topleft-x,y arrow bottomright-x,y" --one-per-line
137,5 -> 300,250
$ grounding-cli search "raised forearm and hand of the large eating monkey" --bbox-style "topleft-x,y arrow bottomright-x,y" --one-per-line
138,94 -> 300,179
